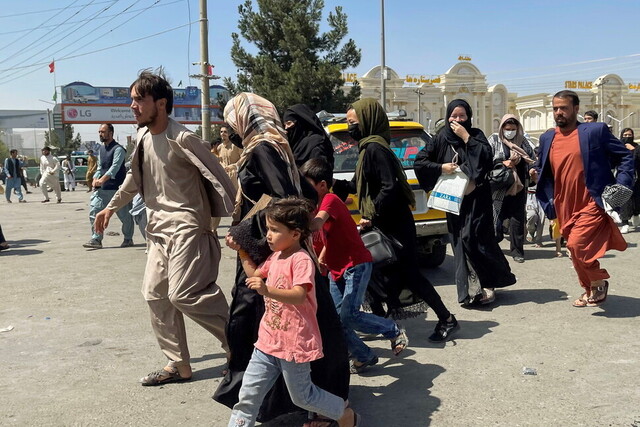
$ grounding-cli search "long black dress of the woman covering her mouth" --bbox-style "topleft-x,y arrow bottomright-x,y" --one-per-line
414,128 -> 516,303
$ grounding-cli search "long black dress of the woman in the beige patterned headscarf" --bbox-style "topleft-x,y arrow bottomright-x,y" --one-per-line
213,143 -> 349,422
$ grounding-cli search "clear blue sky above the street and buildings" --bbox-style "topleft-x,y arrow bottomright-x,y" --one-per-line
0,0 -> 640,140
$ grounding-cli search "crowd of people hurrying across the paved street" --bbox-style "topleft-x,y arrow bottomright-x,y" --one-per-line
0,67 -> 640,427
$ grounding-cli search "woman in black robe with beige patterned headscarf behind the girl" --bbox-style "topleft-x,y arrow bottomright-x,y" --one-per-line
213,93 -> 349,422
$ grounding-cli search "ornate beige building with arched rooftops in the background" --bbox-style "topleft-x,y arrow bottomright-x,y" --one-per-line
345,61 -> 640,141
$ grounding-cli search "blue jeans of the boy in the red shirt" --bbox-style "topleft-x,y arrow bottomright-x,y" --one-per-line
329,262 -> 400,362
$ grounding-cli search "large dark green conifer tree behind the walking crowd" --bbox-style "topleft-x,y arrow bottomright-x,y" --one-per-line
225,0 -> 360,112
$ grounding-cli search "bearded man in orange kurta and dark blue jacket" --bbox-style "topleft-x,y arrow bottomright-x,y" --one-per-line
534,91 -> 633,307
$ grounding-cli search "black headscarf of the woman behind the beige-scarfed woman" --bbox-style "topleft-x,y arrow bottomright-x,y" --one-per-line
282,104 -> 333,168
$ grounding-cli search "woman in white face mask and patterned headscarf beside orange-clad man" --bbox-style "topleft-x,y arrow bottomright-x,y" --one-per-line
489,114 -> 535,263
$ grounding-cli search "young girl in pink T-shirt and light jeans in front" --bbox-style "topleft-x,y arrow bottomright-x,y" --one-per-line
227,197 -> 359,427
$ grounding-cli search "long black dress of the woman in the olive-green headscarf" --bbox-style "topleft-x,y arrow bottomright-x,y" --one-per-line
334,144 -> 451,320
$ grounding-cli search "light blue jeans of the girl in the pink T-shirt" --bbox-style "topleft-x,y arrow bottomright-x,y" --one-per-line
229,348 -> 345,427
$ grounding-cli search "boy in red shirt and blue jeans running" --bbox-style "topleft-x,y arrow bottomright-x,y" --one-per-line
300,158 -> 409,374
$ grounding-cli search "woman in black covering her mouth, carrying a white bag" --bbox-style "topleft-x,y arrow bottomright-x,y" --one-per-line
414,99 -> 516,305
